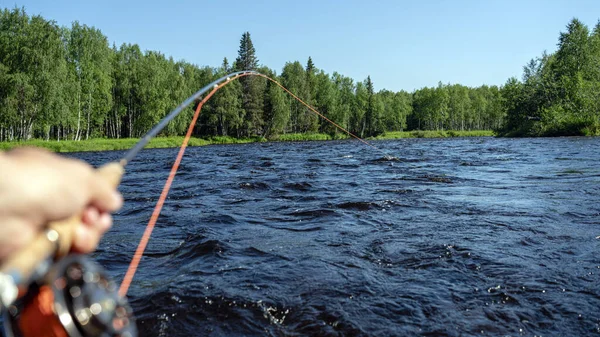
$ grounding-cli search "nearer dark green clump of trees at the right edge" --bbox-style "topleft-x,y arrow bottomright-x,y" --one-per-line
498,19 -> 600,136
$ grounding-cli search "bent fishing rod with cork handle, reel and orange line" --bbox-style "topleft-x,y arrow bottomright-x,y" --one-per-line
0,71 -> 389,337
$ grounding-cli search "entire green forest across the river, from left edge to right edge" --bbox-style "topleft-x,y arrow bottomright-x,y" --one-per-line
0,8 -> 600,141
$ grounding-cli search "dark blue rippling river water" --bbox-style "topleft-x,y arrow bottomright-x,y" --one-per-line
72,138 -> 600,336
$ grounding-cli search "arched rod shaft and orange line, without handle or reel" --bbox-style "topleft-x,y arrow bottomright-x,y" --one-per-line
119,71 -> 395,297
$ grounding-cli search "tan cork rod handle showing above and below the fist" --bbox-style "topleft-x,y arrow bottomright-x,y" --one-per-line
0,162 -> 124,284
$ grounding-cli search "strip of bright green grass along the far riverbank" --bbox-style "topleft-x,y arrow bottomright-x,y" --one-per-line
0,130 -> 494,152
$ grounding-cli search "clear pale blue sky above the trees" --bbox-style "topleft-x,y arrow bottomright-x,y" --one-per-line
0,0 -> 600,92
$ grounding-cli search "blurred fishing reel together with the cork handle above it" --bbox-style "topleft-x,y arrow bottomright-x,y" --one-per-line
0,163 -> 137,337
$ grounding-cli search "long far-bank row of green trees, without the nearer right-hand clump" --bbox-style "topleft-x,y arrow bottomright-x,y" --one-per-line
0,8 -> 505,144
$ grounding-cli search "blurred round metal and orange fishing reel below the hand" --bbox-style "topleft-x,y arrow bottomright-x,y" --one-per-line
4,254 -> 138,337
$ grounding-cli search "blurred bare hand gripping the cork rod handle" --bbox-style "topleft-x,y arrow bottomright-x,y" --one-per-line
0,148 -> 123,262
